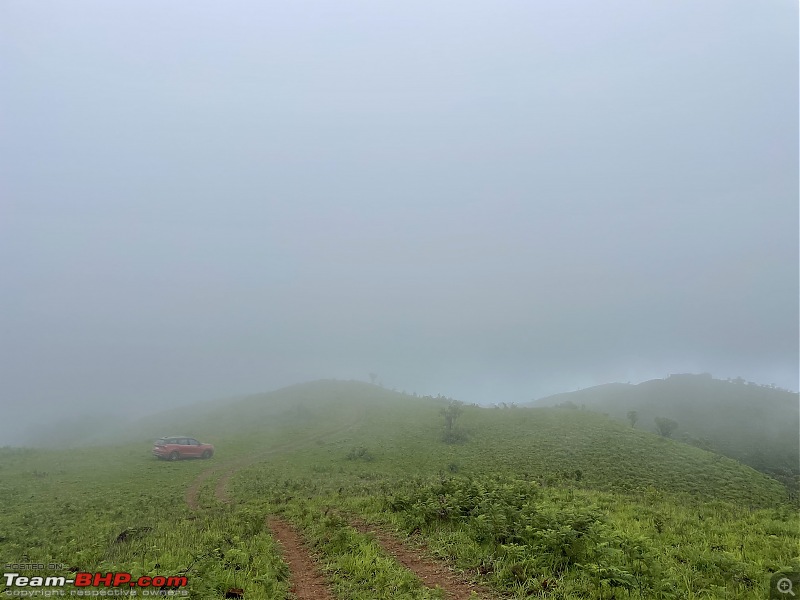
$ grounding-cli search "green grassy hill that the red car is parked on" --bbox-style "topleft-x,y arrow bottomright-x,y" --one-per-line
0,381 -> 800,600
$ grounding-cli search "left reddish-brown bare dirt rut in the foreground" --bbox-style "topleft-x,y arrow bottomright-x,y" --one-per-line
267,517 -> 334,600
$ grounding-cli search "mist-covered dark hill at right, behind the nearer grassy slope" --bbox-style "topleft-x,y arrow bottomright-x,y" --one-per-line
531,373 -> 800,485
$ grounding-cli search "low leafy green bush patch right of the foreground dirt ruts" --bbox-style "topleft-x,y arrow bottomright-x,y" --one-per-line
386,476 -> 653,594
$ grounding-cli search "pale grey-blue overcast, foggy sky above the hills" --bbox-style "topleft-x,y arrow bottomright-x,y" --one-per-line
0,0 -> 798,444
